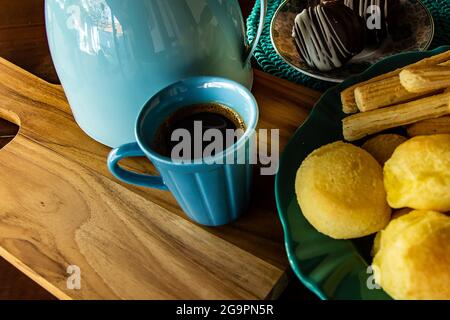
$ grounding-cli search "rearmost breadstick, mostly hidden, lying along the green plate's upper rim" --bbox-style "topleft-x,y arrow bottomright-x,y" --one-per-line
341,50 -> 450,114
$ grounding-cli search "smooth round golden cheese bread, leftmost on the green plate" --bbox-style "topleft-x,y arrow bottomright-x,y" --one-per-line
295,142 -> 391,239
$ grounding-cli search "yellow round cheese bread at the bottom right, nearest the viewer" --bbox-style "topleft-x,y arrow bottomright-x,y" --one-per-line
372,211 -> 450,300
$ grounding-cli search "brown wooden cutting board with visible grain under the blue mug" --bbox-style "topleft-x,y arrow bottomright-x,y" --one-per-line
0,58 -> 319,299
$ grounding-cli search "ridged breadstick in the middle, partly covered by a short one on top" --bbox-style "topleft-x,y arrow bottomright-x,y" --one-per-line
355,76 -> 436,112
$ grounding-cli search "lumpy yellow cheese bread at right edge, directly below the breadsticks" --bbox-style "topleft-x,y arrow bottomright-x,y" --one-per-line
384,134 -> 450,212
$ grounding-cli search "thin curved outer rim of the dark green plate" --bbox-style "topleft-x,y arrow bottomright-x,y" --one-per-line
275,45 -> 450,300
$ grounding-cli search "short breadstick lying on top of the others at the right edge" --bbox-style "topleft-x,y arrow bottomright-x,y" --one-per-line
400,66 -> 450,94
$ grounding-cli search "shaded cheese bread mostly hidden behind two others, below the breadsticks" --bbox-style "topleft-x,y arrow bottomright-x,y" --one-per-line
362,134 -> 407,165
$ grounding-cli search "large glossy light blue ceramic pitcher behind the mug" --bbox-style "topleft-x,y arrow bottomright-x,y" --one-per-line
45,0 -> 266,147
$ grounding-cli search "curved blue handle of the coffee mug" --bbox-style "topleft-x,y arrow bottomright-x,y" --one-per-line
108,142 -> 168,190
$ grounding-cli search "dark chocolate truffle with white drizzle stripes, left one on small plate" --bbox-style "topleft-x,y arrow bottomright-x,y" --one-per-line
293,1 -> 365,71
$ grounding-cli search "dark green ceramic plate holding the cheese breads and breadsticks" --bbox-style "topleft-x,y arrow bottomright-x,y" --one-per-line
275,46 -> 450,300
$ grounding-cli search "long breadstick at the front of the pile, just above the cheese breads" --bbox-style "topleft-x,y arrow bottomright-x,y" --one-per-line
343,93 -> 450,141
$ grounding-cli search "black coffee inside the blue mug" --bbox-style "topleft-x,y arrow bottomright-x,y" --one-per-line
153,103 -> 246,160
